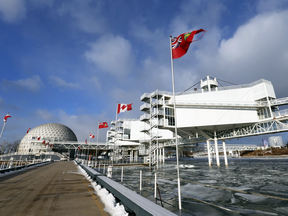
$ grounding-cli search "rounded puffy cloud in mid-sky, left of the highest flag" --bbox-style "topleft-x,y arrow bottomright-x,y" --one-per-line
85,35 -> 135,77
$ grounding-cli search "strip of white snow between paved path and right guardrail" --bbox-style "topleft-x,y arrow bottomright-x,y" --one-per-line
78,166 -> 128,216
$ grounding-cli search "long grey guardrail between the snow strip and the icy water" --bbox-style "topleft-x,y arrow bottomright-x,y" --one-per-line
76,161 -> 175,216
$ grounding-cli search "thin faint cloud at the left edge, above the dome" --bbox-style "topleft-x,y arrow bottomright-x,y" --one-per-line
1,75 -> 43,92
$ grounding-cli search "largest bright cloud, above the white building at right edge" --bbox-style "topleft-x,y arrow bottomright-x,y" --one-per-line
196,11 -> 288,94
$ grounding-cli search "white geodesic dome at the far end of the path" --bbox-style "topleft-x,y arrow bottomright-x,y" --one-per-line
18,123 -> 77,153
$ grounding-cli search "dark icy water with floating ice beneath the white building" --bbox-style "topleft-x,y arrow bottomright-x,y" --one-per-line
108,158 -> 288,216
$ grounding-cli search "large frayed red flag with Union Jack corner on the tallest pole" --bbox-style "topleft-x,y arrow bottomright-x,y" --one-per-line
171,29 -> 207,59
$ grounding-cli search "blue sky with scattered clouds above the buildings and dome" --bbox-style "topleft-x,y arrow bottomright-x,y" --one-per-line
0,0 -> 288,144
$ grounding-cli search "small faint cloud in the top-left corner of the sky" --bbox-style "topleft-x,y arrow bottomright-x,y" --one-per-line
0,0 -> 26,23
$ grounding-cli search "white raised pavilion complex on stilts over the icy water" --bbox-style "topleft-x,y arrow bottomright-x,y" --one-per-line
107,76 -> 288,166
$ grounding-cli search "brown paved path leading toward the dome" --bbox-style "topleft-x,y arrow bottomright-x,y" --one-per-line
0,161 -> 109,216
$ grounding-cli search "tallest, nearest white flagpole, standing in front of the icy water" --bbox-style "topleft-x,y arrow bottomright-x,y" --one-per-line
170,36 -> 182,210
